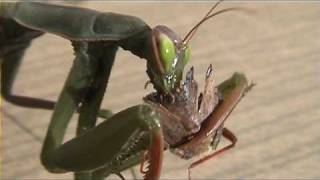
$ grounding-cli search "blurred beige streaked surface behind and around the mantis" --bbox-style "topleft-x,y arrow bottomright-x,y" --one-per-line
1,1 -> 320,179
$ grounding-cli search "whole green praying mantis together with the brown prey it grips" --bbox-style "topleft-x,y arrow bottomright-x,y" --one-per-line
0,1 -> 253,180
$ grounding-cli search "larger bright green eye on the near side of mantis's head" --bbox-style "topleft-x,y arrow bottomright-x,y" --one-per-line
159,34 -> 176,71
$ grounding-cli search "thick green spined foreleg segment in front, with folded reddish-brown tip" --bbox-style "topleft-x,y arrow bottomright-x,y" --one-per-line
52,105 -> 163,178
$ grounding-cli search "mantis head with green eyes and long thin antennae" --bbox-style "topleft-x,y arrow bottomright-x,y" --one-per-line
147,0 -> 248,96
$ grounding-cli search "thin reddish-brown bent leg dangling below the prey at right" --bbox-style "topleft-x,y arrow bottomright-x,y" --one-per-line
188,128 -> 237,180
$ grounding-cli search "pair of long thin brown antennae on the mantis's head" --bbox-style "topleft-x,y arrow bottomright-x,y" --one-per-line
182,0 -> 248,46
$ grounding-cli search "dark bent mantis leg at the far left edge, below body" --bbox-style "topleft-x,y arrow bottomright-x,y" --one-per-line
0,19 -> 55,109
